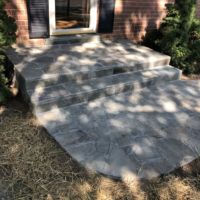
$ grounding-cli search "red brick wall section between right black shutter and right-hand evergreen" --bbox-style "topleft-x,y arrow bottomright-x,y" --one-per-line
110,0 -> 174,41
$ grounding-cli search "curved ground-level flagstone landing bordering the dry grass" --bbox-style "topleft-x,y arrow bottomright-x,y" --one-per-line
36,81 -> 200,179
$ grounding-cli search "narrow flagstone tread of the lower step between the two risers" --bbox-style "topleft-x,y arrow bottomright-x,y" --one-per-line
28,66 -> 179,104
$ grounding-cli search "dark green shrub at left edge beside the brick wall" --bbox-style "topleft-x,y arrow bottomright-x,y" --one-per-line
0,0 -> 17,101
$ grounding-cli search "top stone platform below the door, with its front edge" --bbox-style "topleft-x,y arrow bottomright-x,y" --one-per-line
7,41 -> 170,87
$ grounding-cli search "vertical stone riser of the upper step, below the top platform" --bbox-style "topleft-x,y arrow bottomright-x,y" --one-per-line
26,55 -> 170,90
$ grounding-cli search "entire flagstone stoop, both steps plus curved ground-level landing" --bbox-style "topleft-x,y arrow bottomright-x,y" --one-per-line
7,40 -> 200,179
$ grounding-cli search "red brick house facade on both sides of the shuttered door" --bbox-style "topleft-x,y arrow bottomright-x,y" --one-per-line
3,0 -> 200,45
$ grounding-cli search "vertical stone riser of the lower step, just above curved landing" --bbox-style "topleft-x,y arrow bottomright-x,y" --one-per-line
32,71 -> 181,112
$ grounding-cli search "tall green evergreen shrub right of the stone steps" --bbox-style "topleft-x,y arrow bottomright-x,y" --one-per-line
144,0 -> 200,74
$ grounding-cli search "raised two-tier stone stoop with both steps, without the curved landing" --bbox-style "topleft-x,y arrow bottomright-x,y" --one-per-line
8,40 -> 181,112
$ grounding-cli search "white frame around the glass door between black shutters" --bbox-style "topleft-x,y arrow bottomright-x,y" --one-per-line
49,0 -> 98,35
